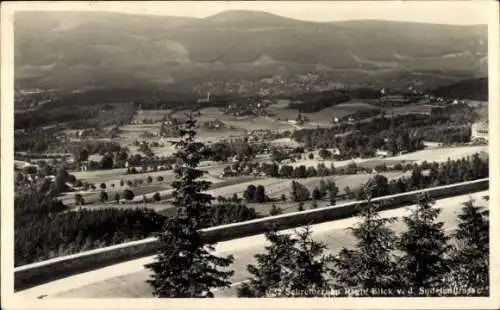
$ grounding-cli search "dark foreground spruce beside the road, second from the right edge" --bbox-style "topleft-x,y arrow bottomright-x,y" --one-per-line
398,195 -> 450,292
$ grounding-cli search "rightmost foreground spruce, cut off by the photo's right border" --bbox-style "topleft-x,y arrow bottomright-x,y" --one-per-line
451,200 -> 490,289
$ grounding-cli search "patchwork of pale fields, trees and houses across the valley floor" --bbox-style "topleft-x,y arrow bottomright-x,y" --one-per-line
15,75 -> 488,220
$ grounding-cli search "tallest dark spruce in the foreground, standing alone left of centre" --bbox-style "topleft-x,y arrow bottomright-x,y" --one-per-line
146,114 -> 233,298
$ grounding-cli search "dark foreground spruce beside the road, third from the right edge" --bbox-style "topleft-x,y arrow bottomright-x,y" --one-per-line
333,189 -> 400,296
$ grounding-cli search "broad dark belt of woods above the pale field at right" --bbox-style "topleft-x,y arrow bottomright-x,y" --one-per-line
292,114 -> 470,150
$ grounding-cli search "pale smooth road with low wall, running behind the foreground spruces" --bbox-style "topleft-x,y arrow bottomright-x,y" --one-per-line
16,191 -> 488,298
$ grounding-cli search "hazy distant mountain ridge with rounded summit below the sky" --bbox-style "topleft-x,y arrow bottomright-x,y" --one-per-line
15,11 -> 487,88
